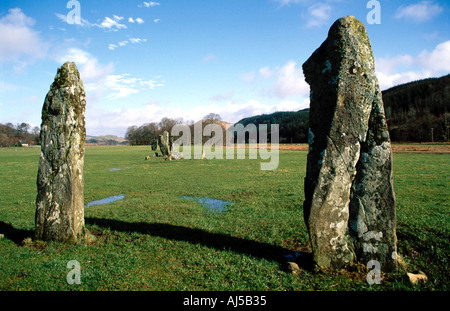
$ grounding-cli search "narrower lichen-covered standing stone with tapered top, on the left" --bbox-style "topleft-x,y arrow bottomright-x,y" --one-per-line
35,62 -> 86,243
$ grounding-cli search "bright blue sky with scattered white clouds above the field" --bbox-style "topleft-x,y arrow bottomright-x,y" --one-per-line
0,0 -> 450,137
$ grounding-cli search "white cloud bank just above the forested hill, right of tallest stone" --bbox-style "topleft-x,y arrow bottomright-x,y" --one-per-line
376,40 -> 450,90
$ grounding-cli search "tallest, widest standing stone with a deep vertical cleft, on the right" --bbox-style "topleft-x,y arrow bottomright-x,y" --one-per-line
303,16 -> 397,272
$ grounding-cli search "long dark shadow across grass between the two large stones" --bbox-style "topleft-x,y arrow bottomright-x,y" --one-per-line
85,218 -> 312,270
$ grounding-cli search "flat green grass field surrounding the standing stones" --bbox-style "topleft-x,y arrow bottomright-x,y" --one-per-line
0,147 -> 450,291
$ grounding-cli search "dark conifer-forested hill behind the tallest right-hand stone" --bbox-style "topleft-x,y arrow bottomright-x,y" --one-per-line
237,75 -> 450,143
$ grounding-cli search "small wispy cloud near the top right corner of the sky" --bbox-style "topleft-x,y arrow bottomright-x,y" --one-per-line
395,1 -> 444,23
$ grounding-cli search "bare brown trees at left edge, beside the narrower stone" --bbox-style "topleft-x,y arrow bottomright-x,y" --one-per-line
0,122 -> 40,147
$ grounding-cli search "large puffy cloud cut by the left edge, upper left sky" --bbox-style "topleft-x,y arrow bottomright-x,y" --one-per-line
0,8 -> 46,64
